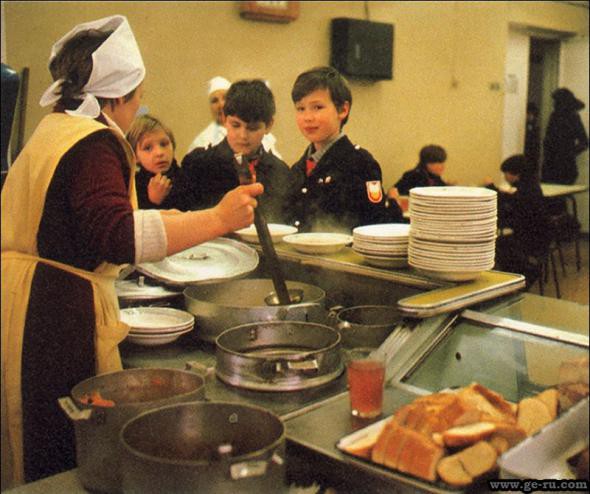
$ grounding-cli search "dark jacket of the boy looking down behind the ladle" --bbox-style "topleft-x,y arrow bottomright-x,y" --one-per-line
181,139 -> 289,223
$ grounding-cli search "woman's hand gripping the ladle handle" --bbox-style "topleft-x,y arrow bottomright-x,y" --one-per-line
213,182 -> 264,233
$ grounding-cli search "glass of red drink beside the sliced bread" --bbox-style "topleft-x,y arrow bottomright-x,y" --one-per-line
347,350 -> 385,418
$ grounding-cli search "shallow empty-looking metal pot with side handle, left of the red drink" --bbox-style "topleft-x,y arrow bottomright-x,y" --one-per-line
215,321 -> 344,391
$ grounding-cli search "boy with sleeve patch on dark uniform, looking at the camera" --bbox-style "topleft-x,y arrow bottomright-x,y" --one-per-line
285,67 -> 403,233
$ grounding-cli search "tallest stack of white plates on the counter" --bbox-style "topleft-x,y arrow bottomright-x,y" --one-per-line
408,187 -> 497,281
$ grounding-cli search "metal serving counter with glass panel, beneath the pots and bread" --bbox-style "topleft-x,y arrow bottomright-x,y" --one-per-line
10,247 -> 589,494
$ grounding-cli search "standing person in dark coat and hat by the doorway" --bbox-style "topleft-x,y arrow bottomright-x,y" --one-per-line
541,88 -> 588,185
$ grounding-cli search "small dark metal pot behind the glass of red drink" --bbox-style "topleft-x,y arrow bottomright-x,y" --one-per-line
328,305 -> 402,348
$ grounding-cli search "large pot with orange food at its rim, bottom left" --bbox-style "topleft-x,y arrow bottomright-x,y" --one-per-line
59,369 -> 205,493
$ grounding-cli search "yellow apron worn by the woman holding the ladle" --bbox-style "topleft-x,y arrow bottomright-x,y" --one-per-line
1,113 -> 137,490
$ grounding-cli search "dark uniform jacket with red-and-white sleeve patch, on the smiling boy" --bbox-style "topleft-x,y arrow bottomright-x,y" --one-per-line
285,136 -> 403,233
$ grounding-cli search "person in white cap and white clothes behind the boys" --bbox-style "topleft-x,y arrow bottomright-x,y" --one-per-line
187,76 -> 282,159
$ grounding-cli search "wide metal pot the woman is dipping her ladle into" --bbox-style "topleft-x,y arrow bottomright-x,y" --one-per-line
184,279 -> 327,342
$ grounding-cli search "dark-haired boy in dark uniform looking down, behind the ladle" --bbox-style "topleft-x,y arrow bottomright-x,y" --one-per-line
181,80 -> 289,223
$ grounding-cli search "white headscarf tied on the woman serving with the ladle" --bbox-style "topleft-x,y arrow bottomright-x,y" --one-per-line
39,15 -> 145,118
